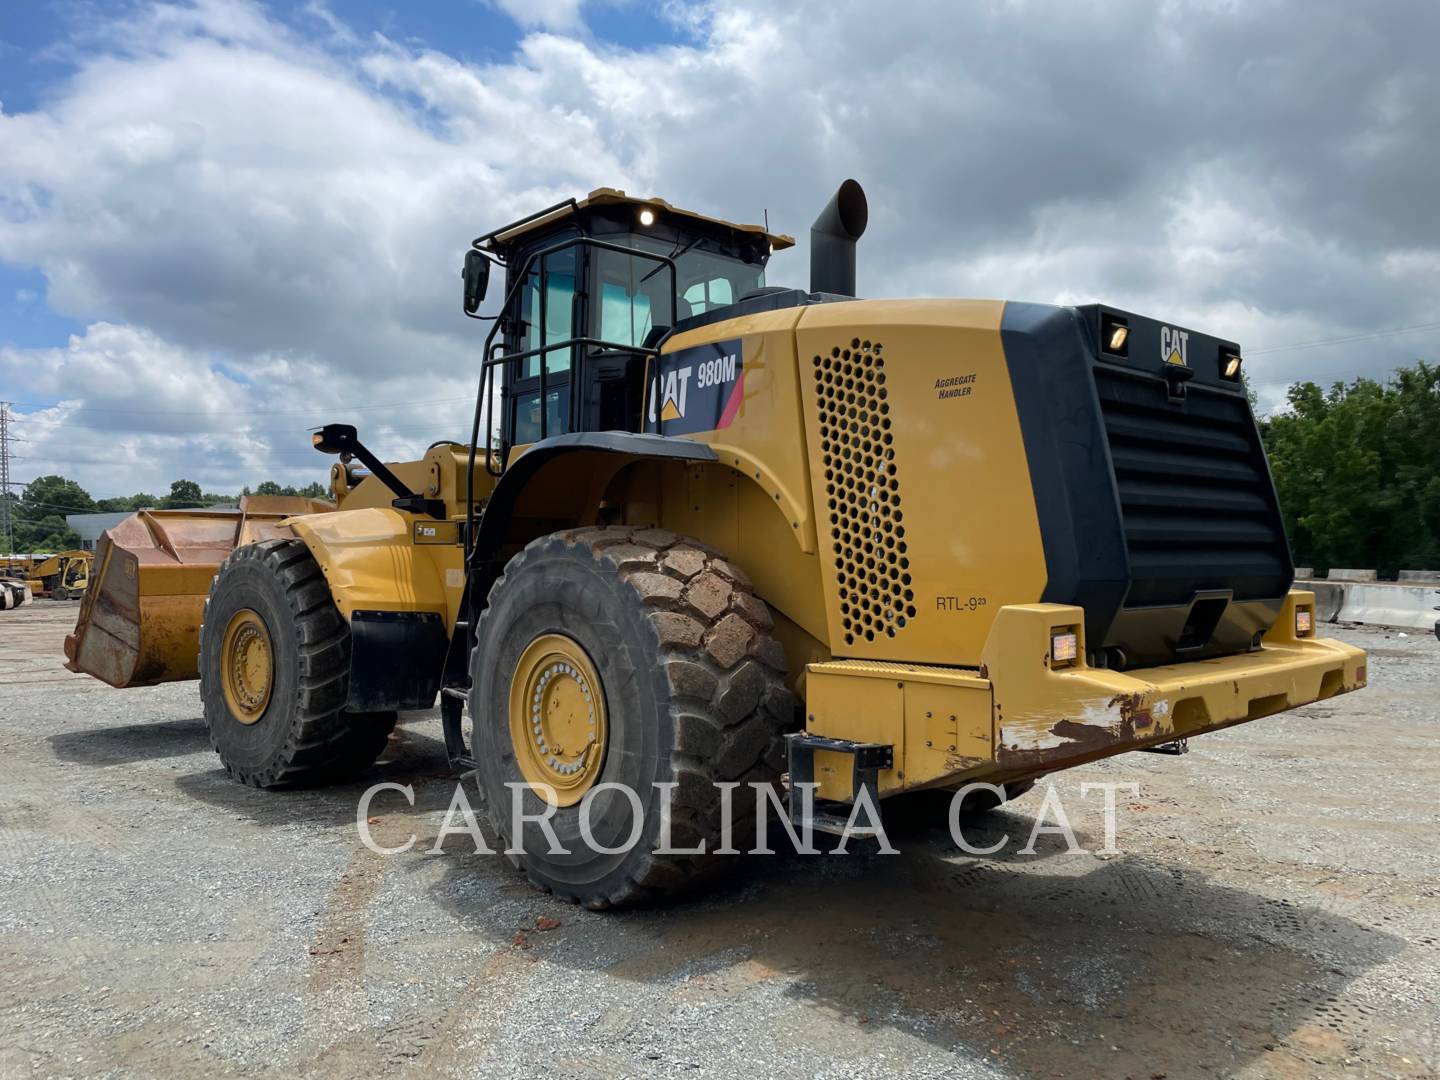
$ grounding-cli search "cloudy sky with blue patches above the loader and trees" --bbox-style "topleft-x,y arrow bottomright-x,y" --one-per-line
0,0 -> 1440,495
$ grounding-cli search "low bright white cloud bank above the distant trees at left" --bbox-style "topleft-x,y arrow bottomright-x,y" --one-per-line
0,323 -> 474,495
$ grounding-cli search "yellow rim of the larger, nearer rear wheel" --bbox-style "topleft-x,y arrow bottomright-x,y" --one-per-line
510,634 -> 609,806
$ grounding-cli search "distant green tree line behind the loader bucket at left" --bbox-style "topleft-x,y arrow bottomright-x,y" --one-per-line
0,475 -> 330,553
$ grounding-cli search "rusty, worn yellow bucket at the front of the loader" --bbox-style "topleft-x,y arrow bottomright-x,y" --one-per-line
65,495 -> 334,687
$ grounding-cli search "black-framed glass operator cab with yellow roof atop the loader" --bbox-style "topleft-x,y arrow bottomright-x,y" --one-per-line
465,187 -> 795,462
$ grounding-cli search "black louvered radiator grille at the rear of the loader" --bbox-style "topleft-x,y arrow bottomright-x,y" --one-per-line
1094,363 -> 1292,608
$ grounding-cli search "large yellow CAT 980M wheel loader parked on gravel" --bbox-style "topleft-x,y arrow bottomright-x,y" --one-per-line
68,181 -> 1365,907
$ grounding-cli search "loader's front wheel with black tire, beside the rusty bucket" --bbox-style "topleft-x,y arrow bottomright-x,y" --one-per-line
200,540 -> 396,788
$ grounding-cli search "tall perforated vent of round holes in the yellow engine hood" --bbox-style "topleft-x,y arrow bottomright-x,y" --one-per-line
814,338 -> 914,645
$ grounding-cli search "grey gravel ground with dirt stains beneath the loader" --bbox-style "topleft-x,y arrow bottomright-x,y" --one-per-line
0,600 -> 1440,1080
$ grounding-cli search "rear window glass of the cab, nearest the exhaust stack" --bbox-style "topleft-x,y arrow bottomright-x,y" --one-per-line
595,233 -> 765,346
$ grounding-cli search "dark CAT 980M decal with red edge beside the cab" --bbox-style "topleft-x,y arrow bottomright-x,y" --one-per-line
645,338 -> 744,435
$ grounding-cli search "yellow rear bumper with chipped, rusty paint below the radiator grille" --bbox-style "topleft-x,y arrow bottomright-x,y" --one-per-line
805,590 -> 1367,799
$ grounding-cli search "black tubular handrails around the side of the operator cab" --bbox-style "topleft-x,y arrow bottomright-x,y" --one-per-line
465,237 -> 680,573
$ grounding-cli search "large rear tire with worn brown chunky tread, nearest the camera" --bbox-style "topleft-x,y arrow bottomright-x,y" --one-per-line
469,527 -> 795,909
